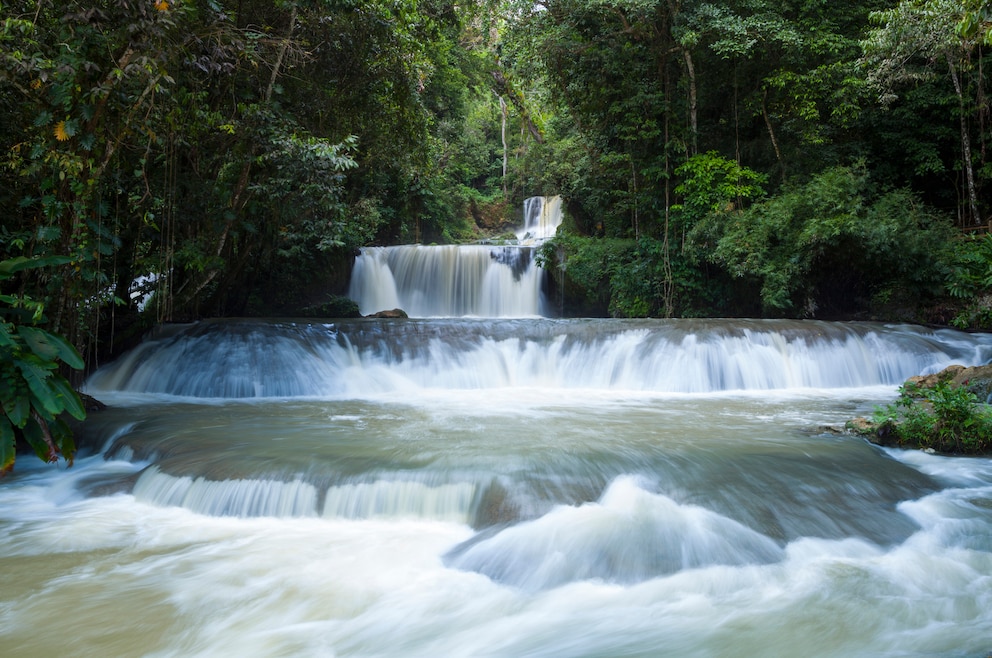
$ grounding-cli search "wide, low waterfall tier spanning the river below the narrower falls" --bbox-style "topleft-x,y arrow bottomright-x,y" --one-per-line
87,319 -> 992,398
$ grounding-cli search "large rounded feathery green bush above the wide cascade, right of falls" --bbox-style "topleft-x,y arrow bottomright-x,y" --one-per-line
690,165 -> 950,316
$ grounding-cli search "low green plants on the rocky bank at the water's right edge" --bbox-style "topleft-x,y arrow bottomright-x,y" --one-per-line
872,381 -> 992,453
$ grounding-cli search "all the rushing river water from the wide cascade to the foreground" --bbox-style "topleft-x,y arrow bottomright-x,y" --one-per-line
0,319 -> 992,657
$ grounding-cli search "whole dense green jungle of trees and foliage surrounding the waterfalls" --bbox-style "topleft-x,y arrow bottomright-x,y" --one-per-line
0,0 -> 992,470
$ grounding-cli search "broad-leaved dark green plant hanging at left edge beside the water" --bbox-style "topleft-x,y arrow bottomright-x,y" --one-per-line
0,257 -> 86,476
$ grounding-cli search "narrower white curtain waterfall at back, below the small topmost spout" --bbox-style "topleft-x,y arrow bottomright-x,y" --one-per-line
348,245 -> 546,318
